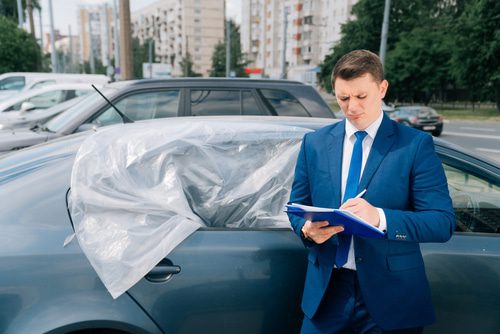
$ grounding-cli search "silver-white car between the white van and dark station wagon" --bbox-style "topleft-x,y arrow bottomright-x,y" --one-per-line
0,83 -> 95,117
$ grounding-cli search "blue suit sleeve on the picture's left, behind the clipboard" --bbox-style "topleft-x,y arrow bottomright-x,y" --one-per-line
288,134 -> 315,247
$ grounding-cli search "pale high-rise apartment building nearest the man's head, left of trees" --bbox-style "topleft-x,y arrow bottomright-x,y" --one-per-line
241,0 -> 357,85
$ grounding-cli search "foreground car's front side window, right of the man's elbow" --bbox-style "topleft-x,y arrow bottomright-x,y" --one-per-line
443,164 -> 500,233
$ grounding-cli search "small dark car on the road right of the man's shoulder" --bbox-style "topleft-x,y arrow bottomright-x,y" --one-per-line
389,106 -> 443,137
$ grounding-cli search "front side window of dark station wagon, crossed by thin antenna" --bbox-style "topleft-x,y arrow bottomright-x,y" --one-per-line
92,90 -> 179,126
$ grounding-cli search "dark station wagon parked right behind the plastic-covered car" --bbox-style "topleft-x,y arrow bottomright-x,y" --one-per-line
0,78 -> 335,153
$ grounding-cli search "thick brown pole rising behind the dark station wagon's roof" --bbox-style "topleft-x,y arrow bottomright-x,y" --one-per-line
120,0 -> 134,80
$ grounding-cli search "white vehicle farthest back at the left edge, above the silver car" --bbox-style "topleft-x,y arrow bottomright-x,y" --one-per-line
0,72 -> 110,101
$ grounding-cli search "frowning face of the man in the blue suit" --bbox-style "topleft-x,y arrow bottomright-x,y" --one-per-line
334,73 -> 389,130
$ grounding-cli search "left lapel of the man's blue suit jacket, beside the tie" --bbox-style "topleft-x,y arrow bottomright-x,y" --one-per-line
326,120 -> 345,208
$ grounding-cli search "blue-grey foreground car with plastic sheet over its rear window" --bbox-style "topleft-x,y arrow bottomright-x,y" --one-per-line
0,116 -> 500,334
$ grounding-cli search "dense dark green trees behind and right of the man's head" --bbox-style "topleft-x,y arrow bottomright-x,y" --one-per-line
320,0 -> 500,109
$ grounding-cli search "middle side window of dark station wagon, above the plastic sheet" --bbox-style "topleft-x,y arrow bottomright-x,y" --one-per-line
191,89 -> 242,116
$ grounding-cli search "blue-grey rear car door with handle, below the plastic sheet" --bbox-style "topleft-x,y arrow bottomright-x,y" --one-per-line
128,228 -> 307,333
